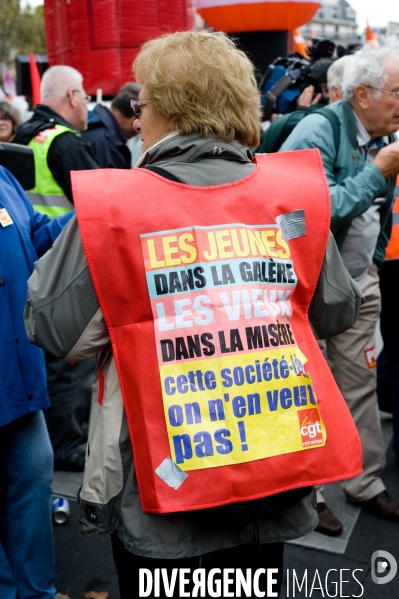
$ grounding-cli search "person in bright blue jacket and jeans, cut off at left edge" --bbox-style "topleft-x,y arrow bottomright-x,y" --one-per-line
0,166 -> 74,599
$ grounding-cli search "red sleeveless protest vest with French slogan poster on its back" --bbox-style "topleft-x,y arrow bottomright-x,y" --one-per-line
72,150 -> 361,513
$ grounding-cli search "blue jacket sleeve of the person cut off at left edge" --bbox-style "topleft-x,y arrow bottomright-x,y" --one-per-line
0,167 -> 75,258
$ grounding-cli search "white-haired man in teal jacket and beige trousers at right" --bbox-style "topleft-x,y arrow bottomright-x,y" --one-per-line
281,44 -> 399,535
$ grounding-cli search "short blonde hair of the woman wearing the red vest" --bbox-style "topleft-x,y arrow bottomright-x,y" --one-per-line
133,31 -> 260,147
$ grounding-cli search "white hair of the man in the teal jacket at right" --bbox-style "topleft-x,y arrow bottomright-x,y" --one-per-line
342,41 -> 399,102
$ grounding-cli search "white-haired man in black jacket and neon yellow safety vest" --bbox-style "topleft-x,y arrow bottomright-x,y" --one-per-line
14,66 -> 99,471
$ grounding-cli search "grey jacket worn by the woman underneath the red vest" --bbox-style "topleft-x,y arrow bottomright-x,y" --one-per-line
25,134 -> 361,558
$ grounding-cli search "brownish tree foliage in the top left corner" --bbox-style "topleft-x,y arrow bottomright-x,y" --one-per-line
0,0 -> 47,70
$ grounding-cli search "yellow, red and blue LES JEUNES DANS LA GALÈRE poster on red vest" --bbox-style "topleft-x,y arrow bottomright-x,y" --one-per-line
141,224 -> 326,471
